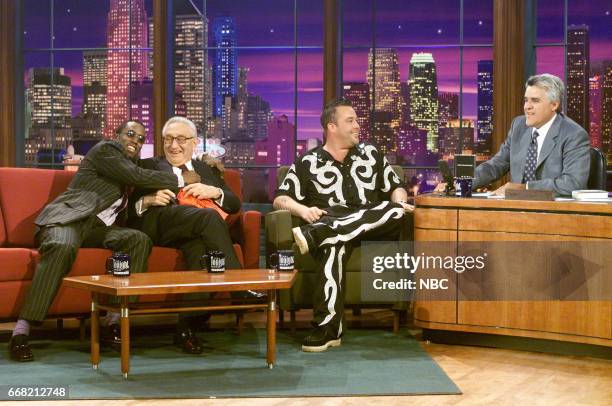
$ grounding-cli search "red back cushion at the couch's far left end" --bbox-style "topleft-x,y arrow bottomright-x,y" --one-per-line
0,168 -> 75,247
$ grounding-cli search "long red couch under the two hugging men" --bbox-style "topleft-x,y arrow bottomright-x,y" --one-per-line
0,168 -> 261,320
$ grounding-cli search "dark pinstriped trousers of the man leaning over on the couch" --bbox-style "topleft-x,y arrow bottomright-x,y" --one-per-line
19,216 -> 153,322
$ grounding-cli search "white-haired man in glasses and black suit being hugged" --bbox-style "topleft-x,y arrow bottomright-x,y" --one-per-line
128,117 -> 258,354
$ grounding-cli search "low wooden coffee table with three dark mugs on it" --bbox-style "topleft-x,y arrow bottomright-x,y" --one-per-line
64,269 -> 297,378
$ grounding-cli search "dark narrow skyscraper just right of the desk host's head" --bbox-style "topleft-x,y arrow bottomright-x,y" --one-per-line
567,25 -> 590,129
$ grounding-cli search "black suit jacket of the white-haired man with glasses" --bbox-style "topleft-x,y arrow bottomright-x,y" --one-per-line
128,157 -> 240,241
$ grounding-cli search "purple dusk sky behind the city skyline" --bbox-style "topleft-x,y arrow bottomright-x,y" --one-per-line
24,0 -> 612,138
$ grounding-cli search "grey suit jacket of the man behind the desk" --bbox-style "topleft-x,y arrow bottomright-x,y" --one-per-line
473,114 -> 591,195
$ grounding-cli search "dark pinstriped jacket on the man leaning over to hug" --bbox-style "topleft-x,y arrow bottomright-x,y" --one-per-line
35,141 -> 178,226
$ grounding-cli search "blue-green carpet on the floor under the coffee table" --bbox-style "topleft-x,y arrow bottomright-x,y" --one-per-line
0,328 -> 461,399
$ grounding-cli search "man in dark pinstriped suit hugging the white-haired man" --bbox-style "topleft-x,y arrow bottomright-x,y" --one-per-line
9,121 -> 193,362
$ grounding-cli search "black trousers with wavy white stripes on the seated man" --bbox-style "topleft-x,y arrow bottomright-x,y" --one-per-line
303,201 -> 404,337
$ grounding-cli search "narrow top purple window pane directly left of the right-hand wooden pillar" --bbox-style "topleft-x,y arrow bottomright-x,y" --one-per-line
463,0 -> 493,44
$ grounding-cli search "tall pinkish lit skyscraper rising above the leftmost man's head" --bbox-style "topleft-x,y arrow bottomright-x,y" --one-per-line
104,0 -> 149,137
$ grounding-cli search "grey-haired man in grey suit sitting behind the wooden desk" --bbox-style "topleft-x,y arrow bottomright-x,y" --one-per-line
436,74 -> 591,195
